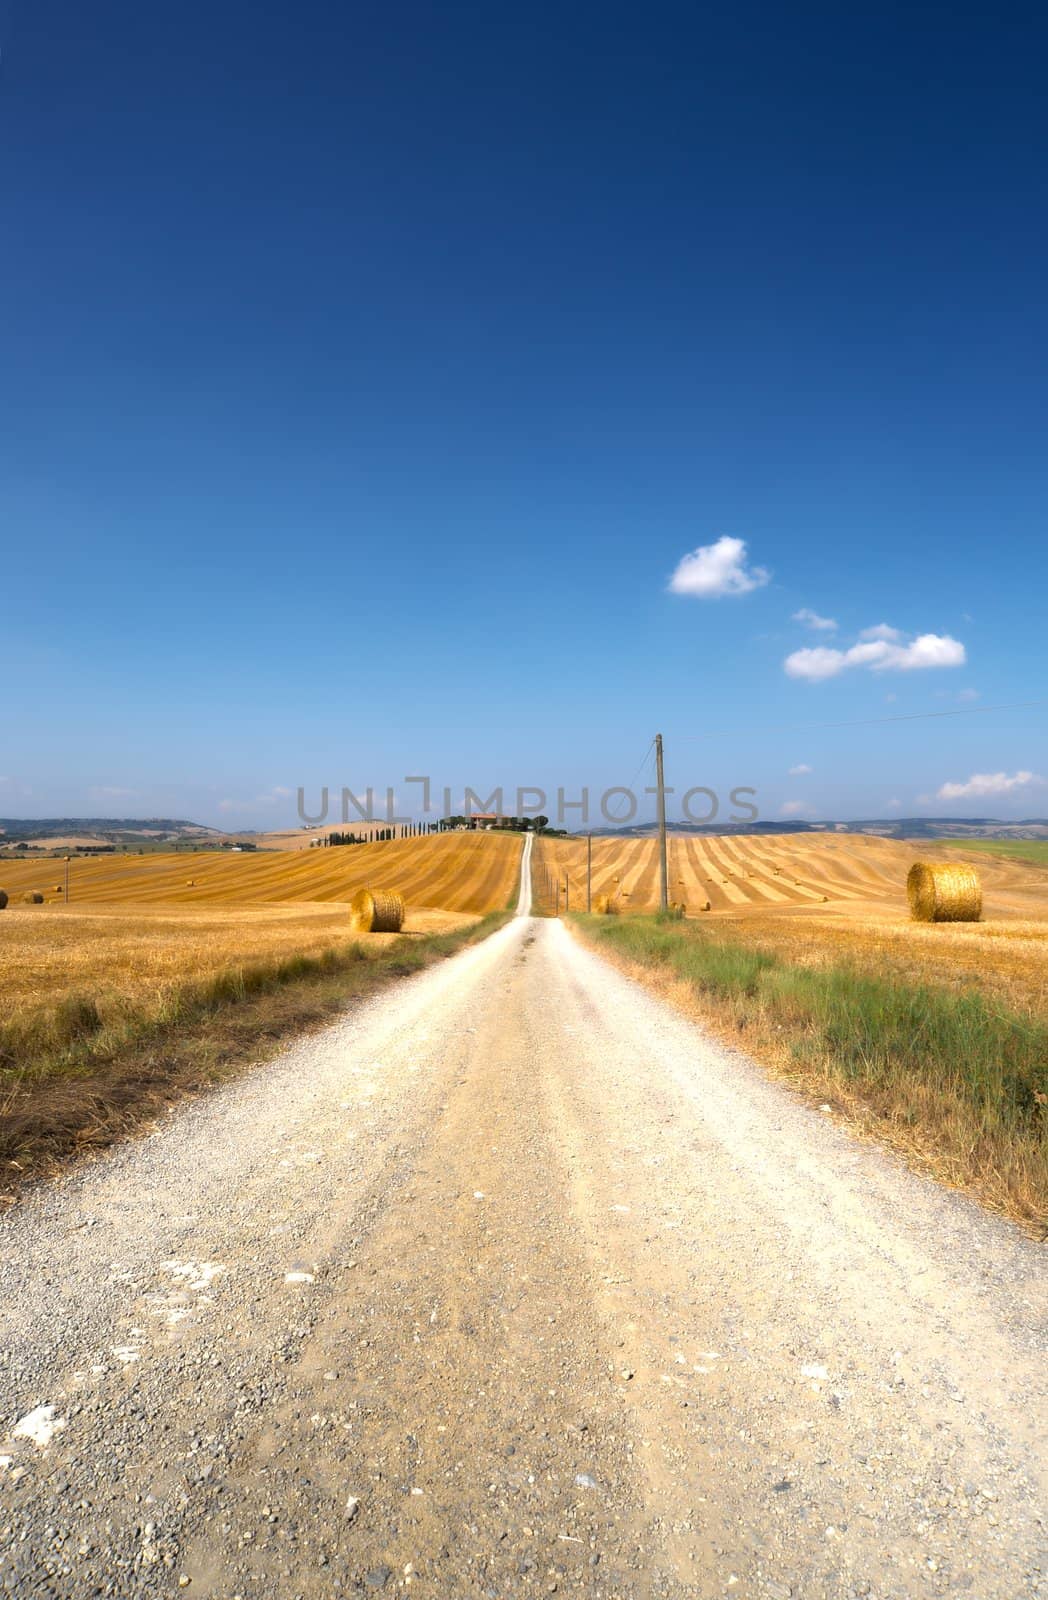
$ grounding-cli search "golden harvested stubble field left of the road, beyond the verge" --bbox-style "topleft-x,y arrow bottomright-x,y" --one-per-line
0,834 -> 522,1043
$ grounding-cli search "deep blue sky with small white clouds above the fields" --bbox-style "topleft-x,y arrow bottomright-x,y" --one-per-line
0,0 -> 1048,826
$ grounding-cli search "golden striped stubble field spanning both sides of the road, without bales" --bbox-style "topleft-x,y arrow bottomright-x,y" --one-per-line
0,834 -> 1048,1021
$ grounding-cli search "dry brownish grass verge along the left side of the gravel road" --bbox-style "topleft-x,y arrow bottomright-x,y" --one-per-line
0,910 -> 510,1202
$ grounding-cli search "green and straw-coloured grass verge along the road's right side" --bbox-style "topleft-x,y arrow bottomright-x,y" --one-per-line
574,917 -> 1048,1232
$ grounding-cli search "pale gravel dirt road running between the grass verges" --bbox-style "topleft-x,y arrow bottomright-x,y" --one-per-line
0,844 -> 1048,1600
